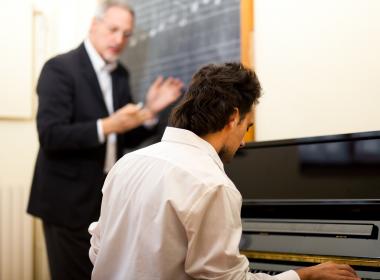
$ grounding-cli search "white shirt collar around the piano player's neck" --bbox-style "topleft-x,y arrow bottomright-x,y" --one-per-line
161,127 -> 224,171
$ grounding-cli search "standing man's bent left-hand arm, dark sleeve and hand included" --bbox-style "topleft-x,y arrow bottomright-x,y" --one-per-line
37,58 -> 152,151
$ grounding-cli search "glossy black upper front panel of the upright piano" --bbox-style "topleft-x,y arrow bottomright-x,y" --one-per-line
225,131 -> 380,203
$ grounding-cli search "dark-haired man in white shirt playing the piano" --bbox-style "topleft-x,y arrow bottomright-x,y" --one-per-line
89,63 -> 358,280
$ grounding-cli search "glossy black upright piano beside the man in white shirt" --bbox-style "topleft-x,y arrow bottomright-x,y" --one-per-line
225,131 -> 380,279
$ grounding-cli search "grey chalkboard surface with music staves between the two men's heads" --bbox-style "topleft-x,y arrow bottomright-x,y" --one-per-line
122,0 -> 240,101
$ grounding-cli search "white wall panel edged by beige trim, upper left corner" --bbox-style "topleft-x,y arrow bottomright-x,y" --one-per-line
0,0 -> 32,118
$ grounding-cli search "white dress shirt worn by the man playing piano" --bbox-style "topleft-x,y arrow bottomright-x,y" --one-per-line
89,127 -> 299,280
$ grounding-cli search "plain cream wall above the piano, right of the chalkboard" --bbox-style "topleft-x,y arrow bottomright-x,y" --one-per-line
253,0 -> 380,140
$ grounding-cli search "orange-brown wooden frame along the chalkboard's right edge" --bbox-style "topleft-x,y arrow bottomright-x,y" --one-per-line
240,0 -> 255,142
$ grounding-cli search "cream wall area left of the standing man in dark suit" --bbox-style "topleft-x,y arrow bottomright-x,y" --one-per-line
0,0 -> 96,280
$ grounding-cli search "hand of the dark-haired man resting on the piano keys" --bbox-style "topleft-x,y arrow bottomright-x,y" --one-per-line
296,262 -> 360,280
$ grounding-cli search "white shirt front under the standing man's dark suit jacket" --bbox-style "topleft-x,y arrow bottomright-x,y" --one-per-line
84,38 -> 117,173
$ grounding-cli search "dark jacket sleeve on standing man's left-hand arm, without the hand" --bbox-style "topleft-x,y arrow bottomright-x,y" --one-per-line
37,59 -> 99,150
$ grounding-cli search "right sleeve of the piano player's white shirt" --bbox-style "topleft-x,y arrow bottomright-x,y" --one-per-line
184,186 -> 300,280
